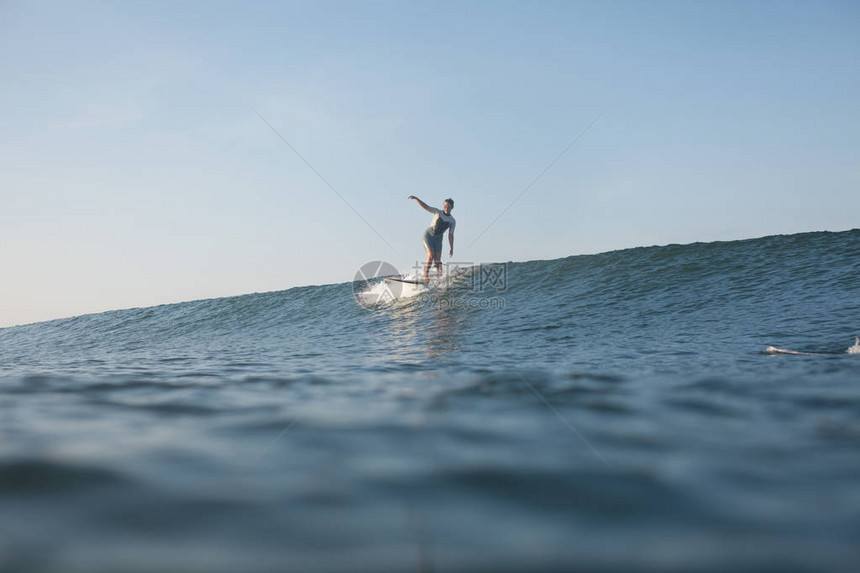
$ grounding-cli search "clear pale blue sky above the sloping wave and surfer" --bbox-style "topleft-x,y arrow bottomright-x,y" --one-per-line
0,0 -> 860,327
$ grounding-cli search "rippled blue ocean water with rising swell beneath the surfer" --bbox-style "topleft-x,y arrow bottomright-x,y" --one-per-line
0,230 -> 860,571
